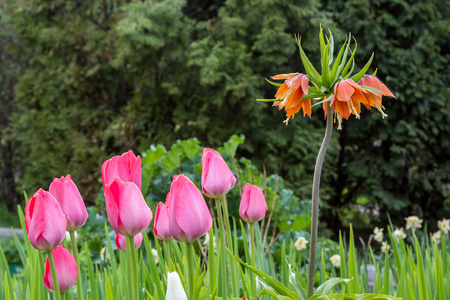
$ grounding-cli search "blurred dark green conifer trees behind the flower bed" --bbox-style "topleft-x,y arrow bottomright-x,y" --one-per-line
0,0 -> 450,232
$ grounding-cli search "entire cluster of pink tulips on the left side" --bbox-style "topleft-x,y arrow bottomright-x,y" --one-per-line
25,148 -> 267,300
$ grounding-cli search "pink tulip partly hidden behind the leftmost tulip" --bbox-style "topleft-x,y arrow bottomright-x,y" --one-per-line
50,175 -> 88,231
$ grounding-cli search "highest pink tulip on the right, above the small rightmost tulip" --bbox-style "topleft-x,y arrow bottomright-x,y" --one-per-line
202,148 -> 236,199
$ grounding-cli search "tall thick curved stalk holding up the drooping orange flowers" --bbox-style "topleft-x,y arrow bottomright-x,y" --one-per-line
307,102 -> 333,298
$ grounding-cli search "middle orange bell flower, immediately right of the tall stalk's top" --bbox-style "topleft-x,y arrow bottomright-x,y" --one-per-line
323,78 -> 369,129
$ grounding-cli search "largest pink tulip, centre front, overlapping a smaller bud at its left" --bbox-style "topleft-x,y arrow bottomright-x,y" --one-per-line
169,175 -> 212,243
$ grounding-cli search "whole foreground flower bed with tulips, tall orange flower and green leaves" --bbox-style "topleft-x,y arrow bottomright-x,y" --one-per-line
0,29 -> 450,300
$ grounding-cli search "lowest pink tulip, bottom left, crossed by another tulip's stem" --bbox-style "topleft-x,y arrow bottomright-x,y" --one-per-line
44,245 -> 78,293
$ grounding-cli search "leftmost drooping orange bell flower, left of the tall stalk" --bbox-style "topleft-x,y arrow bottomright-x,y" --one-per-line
272,73 -> 311,124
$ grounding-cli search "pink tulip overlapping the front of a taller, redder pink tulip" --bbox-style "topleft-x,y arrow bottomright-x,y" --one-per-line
104,178 -> 153,236
